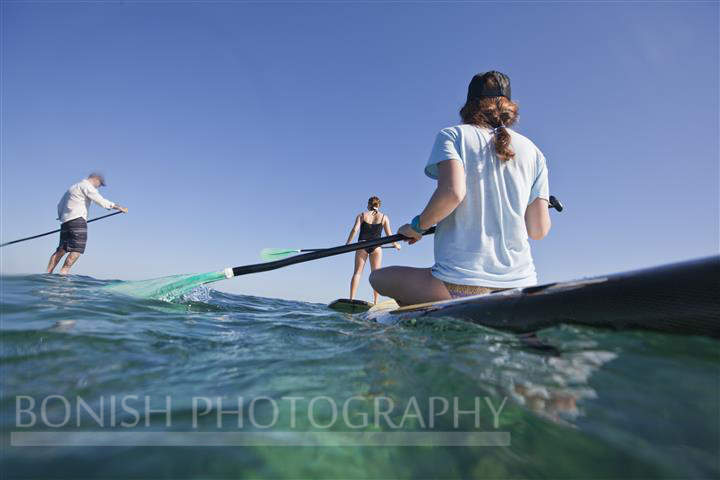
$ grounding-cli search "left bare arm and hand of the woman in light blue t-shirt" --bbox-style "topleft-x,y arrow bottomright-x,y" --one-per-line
398,160 -> 466,244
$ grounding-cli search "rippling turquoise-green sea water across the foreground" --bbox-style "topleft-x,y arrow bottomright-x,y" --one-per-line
0,275 -> 720,479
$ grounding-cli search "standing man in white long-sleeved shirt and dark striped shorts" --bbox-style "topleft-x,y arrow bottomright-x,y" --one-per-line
47,173 -> 128,275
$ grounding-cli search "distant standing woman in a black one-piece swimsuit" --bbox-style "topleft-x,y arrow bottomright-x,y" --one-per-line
345,197 -> 400,303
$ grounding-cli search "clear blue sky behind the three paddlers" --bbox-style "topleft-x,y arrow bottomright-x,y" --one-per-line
0,1 -> 719,302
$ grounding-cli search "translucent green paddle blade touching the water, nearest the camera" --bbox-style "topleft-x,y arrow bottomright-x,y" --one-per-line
103,270 -> 232,301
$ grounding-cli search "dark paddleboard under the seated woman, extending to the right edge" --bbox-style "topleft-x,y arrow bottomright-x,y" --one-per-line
366,256 -> 720,338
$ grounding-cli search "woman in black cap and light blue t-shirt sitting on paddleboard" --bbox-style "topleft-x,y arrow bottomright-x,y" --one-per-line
370,71 -> 550,305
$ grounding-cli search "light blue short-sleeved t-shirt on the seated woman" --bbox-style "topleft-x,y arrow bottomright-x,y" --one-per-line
425,125 -> 549,288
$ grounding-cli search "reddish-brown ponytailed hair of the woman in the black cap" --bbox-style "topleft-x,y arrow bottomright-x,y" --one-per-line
460,75 -> 519,162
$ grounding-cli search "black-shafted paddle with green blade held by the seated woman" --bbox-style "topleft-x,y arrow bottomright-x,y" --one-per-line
105,196 -> 563,300
